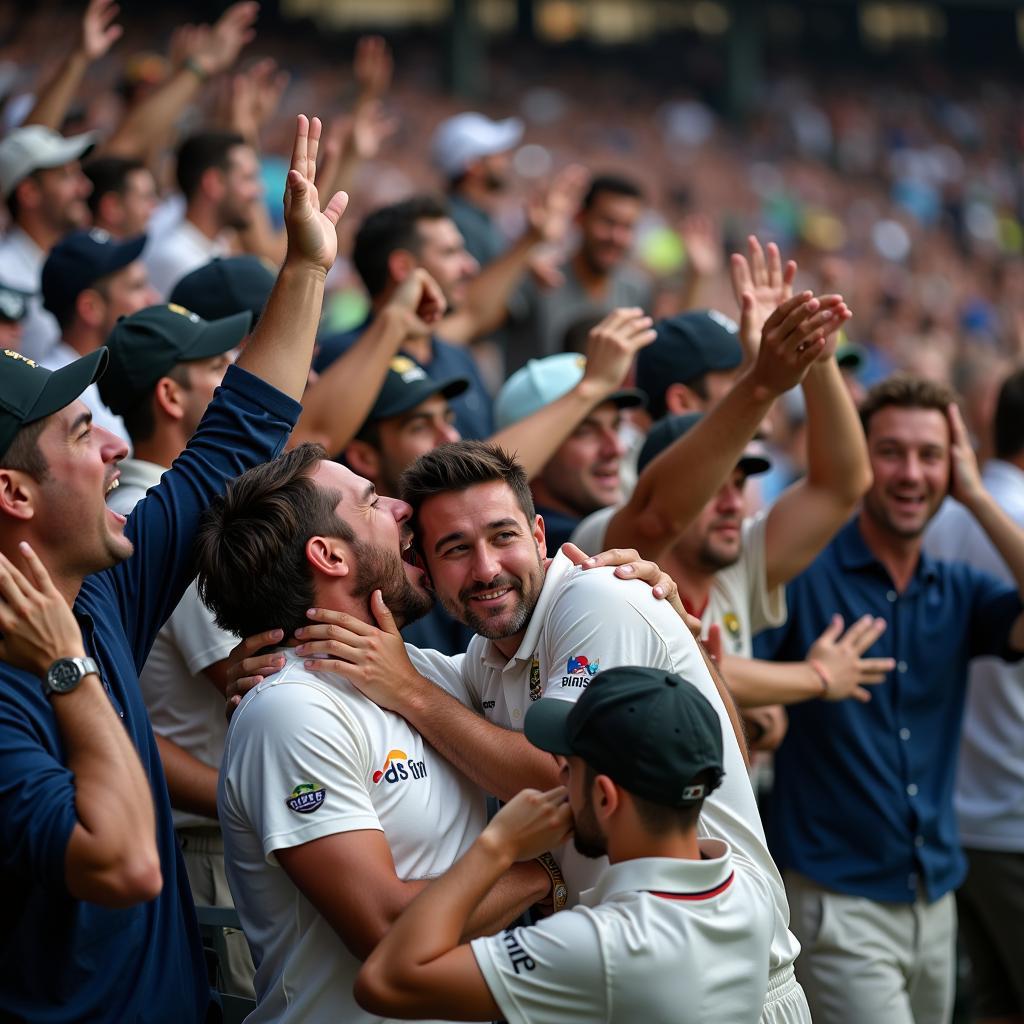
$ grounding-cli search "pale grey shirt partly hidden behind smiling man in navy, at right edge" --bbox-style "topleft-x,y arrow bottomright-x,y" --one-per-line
925,459 -> 1024,853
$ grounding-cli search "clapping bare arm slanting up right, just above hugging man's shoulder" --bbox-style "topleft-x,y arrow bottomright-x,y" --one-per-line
605,292 -> 849,559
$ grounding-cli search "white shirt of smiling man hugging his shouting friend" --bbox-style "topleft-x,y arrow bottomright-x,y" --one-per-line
418,553 -> 800,970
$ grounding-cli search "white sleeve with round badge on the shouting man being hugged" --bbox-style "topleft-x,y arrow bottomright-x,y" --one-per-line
222,682 -> 383,863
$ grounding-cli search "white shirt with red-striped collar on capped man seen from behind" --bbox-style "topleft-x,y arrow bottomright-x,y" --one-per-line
472,840 -> 774,1024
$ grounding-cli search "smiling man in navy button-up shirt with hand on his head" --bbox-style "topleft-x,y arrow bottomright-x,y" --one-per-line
756,377 -> 1024,1024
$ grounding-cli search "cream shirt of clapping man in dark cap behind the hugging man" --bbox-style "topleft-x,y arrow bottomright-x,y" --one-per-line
571,508 -> 786,657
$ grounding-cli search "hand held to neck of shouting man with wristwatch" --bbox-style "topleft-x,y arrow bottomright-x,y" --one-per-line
0,541 -> 85,679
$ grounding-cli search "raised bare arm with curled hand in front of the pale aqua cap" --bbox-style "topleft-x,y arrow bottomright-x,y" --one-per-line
490,308 -> 654,479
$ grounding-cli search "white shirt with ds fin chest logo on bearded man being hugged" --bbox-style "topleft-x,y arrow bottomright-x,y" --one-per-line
217,650 -> 485,1024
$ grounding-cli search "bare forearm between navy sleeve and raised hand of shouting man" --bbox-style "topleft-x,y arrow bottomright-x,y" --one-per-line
239,259 -> 327,401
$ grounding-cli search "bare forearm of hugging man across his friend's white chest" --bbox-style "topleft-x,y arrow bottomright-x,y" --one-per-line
395,680 -> 558,800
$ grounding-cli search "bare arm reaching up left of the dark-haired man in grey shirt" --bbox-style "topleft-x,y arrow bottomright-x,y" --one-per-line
438,166 -> 587,344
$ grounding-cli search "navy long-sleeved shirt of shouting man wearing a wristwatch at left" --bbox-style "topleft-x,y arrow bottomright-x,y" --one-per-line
0,367 -> 301,1024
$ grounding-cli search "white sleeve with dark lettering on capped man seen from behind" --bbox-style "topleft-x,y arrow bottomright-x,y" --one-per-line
470,910 -> 608,1024
